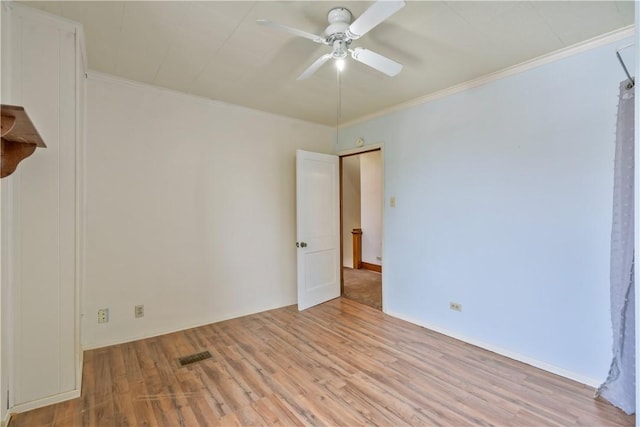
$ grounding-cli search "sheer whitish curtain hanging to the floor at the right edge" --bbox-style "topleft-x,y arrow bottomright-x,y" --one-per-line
596,81 -> 636,414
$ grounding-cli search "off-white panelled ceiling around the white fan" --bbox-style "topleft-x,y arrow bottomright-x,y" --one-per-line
20,0 -> 634,125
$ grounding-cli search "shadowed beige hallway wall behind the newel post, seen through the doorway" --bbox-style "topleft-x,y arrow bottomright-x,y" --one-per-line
342,156 -> 360,268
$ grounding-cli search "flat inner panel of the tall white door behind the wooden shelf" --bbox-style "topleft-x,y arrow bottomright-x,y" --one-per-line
15,13 -> 60,403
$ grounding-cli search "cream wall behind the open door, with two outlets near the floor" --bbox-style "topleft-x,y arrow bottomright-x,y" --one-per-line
82,74 -> 335,348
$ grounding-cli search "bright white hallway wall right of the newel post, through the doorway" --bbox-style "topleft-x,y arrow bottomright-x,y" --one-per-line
359,151 -> 382,265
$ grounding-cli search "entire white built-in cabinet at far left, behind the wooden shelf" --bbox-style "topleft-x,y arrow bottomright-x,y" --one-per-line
0,2 -> 85,414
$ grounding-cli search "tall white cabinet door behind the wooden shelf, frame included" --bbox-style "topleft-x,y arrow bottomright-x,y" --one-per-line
9,7 -> 78,406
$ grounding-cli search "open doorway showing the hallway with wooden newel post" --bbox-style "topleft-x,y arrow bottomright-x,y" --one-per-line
340,148 -> 383,310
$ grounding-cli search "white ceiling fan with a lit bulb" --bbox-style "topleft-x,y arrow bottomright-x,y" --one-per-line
256,0 -> 405,80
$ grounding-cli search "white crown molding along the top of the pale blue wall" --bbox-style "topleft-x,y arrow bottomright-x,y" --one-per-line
338,25 -> 635,128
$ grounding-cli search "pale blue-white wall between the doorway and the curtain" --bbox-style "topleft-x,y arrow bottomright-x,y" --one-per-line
337,35 -> 630,385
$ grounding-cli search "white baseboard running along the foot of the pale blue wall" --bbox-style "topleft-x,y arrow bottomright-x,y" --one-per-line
385,311 -> 602,388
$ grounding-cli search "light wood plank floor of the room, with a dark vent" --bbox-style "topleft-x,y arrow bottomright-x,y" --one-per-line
10,298 -> 634,427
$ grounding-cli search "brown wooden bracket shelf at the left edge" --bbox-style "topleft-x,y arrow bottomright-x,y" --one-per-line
0,104 -> 46,178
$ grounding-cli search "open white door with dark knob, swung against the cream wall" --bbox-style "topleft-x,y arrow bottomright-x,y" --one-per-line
296,150 -> 340,310
